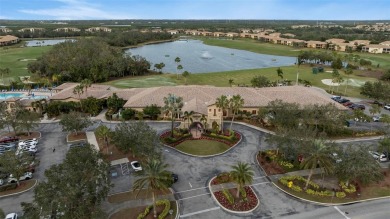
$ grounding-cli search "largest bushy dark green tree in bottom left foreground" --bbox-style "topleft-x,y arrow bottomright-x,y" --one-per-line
22,145 -> 111,218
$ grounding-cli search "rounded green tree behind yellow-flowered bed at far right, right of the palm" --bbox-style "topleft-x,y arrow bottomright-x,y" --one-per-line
335,145 -> 383,185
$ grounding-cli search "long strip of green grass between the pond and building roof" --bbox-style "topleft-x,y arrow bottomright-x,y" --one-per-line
105,66 -> 375,97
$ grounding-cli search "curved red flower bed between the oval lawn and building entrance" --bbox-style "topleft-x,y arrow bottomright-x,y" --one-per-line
160,131 -> 241,147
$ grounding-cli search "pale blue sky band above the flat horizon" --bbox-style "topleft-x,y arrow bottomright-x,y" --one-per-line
0,0 -> 390,20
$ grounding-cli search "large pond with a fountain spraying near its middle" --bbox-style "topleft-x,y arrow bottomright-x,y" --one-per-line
126,40 -> 296,73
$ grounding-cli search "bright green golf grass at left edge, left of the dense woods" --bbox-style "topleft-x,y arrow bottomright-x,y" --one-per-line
0,46 -> 52,84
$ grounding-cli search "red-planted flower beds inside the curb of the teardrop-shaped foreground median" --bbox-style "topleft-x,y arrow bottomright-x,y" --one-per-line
210,175 -> 259,212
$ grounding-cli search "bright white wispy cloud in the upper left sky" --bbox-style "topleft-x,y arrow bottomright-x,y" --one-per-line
19,0 -> 130,20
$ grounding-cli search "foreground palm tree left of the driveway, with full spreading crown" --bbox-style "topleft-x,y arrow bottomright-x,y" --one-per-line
133,159 -> 172,217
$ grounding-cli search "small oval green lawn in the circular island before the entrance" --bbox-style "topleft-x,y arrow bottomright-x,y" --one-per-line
175,140 -> 230,156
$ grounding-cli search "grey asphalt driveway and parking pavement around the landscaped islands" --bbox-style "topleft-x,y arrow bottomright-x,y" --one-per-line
0,122 -> 390,219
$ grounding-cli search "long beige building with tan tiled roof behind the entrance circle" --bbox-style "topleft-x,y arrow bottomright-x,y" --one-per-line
51,83 -> 346,126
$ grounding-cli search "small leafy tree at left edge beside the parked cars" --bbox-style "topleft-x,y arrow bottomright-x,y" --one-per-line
0,150 -> 33,186
